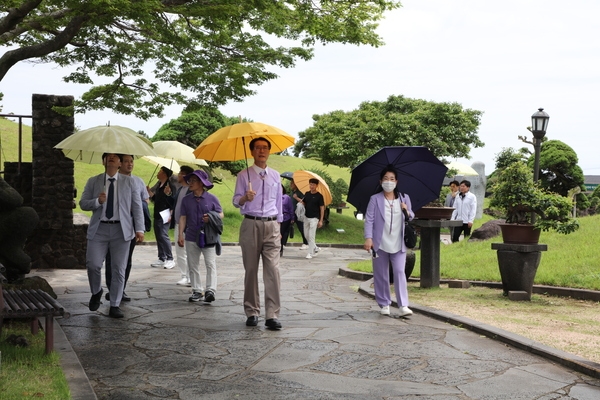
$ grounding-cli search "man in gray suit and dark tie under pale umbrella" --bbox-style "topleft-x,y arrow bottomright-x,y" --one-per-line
79,153 -> 144,318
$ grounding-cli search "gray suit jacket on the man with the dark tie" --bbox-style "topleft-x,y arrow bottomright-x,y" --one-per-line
79,173 -> 144,240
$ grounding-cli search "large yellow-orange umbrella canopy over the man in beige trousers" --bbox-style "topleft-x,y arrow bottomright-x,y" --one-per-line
194,122 -> 295,161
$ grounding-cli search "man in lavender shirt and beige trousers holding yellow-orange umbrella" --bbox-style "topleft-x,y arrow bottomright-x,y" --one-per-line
233,137 -> 283,329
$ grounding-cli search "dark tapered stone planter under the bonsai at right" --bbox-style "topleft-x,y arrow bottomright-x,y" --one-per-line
492,243 -> 548,300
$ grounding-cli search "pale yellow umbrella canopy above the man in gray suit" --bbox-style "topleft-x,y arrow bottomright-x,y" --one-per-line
54,125 -> 156,164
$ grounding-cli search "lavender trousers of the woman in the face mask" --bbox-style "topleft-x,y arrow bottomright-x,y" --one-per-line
373,249 -> 408,307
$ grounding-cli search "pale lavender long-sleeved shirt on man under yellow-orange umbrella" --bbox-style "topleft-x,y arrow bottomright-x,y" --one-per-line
232,165 -> 283,222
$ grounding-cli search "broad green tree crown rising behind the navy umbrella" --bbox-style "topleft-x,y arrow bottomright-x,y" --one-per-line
294,96 -> 483,168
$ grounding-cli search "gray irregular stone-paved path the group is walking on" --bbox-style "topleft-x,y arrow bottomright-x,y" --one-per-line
32,246 -> 600,400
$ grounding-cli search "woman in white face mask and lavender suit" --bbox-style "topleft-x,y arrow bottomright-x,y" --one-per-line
364,165 -> 414,317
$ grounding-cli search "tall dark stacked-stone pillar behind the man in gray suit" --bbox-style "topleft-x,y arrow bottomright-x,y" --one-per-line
26,94 -> 87,269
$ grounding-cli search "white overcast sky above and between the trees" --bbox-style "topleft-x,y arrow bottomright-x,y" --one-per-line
0,0 -> 600,175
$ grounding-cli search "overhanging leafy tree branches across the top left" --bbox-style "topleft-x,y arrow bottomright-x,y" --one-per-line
0,0 -> 400,119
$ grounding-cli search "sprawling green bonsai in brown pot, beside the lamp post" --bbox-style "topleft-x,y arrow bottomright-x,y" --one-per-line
490,161 -> 579,243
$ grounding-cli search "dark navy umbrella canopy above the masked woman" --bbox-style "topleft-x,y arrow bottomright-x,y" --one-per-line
348,146 -> 448,214
